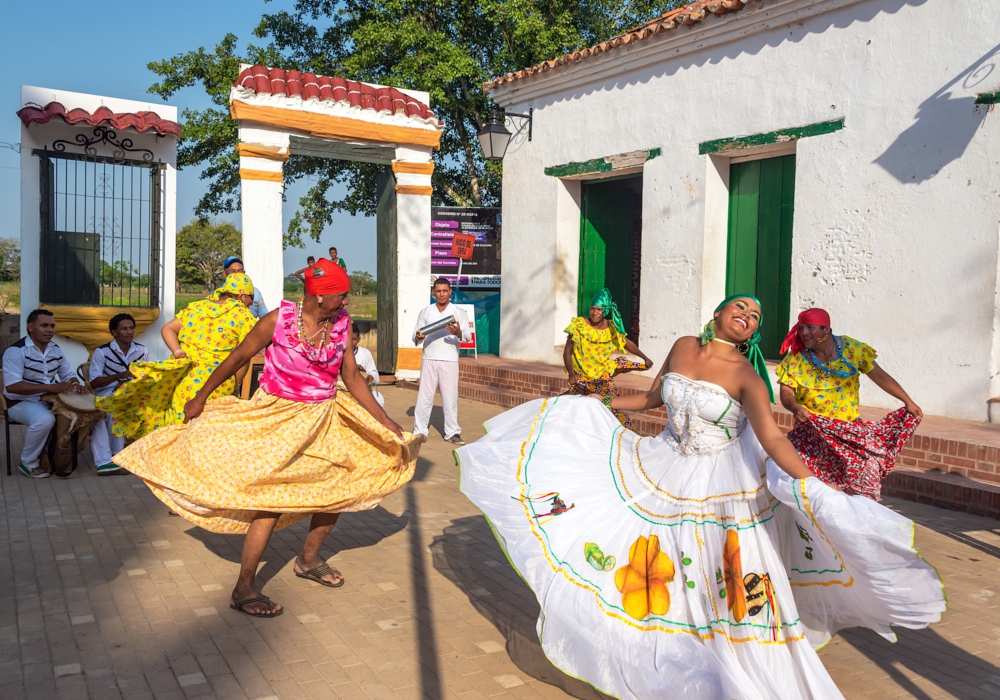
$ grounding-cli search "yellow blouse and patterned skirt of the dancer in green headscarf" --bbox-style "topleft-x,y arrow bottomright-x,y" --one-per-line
565,316 -> 646,428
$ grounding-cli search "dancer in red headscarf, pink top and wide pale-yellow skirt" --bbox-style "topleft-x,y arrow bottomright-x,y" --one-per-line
115,259 -> 421,617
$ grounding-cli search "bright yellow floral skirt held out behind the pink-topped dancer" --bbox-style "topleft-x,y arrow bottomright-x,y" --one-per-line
96,359 -> 236,439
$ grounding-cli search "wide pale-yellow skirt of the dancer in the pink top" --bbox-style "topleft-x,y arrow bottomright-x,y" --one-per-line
115,390 -> 422,534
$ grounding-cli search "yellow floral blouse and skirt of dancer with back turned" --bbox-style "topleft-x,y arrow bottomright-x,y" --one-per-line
96,299 -> 257,438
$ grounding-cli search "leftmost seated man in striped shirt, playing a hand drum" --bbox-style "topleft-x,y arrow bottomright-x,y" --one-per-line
3,309 -> 87,479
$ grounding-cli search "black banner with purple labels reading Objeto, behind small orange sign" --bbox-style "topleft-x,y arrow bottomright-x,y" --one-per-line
431,207 -> 500,289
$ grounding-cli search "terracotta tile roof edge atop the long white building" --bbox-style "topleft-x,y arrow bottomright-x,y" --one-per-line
483,0 -> 758,92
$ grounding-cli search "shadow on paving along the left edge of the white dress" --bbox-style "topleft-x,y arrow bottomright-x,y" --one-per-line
431,516 -> 608,700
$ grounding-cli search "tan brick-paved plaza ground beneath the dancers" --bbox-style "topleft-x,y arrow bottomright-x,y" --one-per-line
0,387 -> 1000,700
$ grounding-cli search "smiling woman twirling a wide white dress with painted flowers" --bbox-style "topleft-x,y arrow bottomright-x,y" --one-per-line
456,295 -> 945,700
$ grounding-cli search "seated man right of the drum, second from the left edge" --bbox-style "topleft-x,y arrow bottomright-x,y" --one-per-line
90,314 -> 149,476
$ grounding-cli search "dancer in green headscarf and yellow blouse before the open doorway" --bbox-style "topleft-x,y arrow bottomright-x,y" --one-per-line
563,289 -> 653,428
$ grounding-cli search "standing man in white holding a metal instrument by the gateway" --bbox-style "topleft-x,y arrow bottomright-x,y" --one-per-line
413,277 -> 471,445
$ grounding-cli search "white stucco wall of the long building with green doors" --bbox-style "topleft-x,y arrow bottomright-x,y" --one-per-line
491,0 -> 1000,420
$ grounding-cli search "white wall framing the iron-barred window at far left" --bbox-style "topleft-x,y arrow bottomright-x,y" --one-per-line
21,85 -> 177,368
